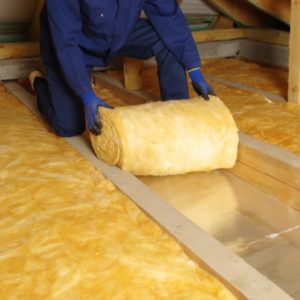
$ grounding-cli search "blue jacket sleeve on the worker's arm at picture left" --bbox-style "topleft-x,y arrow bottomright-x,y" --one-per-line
46,0 -> 92,96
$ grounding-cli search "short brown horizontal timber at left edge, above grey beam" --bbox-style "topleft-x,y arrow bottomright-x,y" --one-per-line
0,42 -> 40,60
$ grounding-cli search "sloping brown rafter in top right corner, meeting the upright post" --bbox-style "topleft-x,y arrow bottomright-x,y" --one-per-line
248,0 -> 291,24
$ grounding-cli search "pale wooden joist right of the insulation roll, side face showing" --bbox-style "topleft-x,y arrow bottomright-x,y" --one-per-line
231,133 -> 300,210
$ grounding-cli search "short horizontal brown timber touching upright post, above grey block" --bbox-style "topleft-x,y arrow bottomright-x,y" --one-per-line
244,28 -> 290,46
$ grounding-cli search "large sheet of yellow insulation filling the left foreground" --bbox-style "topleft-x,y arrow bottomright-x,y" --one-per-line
0,86 -> 235,300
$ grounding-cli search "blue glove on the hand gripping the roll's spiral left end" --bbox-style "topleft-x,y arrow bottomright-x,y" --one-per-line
81,91 -> 111,135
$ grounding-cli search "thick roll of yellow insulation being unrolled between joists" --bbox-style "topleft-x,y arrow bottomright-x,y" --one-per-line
91,97 -> 238,176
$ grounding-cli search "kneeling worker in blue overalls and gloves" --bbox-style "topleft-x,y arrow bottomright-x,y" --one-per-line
30,0 -> 214,137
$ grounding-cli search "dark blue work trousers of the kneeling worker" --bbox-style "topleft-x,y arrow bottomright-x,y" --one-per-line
34,20 -> 188,137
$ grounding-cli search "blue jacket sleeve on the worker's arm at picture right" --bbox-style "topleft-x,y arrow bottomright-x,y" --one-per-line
144,0 -> 200,69
